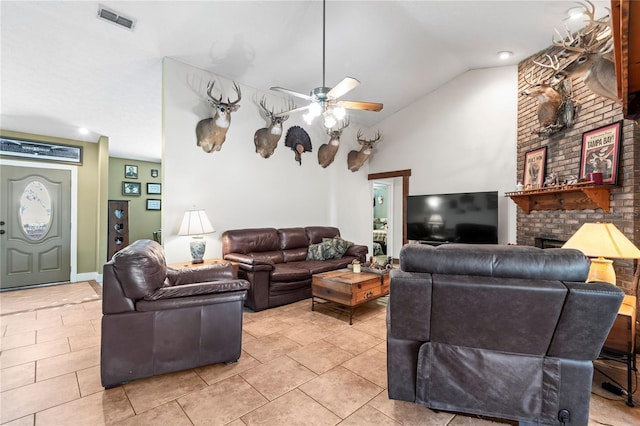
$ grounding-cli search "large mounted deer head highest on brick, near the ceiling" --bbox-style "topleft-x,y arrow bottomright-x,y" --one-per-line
553,1 -> 620,102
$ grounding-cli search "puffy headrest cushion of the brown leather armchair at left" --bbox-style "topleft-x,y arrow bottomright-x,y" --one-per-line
112,240 -> 167,299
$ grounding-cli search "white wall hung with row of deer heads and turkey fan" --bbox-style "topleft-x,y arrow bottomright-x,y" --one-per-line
162,58 -> 371,262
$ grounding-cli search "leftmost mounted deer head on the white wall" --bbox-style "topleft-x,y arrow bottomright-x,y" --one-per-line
196,81 -> 242,152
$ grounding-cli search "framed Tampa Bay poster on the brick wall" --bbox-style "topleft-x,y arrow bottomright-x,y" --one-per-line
579,121 -> 622,185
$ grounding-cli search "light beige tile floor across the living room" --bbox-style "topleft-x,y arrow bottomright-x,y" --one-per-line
0,283 -> 640,426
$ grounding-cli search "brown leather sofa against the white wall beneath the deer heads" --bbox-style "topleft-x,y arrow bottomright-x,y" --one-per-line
222,226 -> 369,311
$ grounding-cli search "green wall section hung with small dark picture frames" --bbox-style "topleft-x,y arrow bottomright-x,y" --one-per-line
109,157 -> 162,245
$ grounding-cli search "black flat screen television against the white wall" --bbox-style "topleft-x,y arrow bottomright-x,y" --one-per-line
406,191 -> 498,245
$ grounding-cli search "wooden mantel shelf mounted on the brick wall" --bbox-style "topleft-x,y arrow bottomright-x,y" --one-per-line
505,182 -> 610,214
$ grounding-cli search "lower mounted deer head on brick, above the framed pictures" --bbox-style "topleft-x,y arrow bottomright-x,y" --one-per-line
522,55 -> 562,127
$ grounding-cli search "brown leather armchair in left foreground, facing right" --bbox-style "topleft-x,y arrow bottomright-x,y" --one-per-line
100,240 -> 249,388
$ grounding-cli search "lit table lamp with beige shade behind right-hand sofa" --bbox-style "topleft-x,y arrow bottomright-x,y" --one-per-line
562,222 -> 640,285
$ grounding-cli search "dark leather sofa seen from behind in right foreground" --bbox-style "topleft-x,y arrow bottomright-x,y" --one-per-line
387,244 -> 623,425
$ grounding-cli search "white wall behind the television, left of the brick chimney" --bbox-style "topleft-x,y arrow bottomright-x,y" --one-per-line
369,66 -> 518,245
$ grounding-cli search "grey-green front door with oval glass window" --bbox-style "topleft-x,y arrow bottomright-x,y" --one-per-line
0,165 -> 71,289
